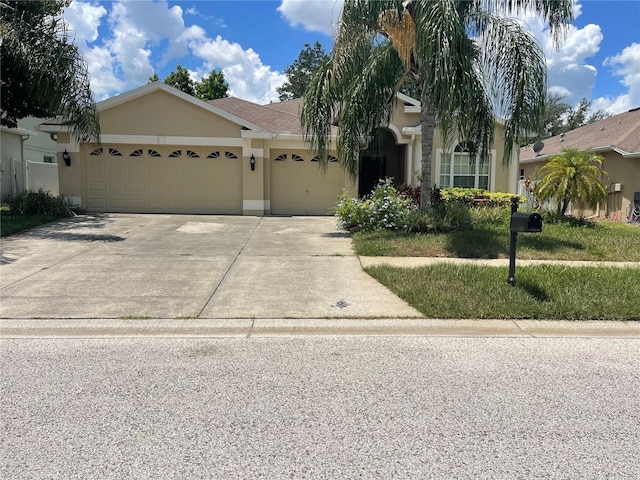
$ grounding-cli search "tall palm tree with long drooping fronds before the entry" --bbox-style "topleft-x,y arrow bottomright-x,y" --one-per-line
301,0 -> 573,209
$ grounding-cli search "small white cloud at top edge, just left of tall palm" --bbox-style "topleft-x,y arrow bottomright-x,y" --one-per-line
278,0 -> 344,36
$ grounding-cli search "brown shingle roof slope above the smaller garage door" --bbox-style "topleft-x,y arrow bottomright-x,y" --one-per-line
209,97 -> 302,135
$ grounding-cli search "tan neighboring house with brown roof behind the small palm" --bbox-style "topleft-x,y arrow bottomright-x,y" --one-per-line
520,108 -> 640,221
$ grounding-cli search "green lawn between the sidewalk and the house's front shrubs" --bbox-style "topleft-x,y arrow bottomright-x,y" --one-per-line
353,222 -> 640,262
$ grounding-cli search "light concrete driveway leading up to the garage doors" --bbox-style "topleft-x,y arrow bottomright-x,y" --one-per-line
0,214 -> 422,319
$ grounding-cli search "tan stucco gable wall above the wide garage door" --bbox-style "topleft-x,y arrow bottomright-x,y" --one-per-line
100,90 -> 241,138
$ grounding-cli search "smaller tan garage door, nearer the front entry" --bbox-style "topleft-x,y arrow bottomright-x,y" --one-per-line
271,153 -> 345,215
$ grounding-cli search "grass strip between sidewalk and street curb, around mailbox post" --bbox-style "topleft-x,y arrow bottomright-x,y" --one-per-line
365,264 -> 640,320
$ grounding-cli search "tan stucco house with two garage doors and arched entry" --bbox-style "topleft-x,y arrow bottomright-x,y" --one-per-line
39,82 -> 518,215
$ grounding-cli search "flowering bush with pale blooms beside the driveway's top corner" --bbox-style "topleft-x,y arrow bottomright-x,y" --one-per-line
335,178 -> 417,232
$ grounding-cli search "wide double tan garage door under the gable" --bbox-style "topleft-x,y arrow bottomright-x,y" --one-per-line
85,145 -> 242,214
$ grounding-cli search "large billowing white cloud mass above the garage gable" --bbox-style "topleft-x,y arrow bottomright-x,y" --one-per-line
65,0 -> 296,103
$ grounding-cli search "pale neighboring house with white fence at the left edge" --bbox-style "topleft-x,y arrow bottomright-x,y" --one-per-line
0,117 -> 58,202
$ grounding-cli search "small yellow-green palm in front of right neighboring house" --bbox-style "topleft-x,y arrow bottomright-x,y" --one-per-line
534,148 -> 608,215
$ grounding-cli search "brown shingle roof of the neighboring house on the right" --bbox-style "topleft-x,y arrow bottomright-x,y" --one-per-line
520,108 -> 640,162
